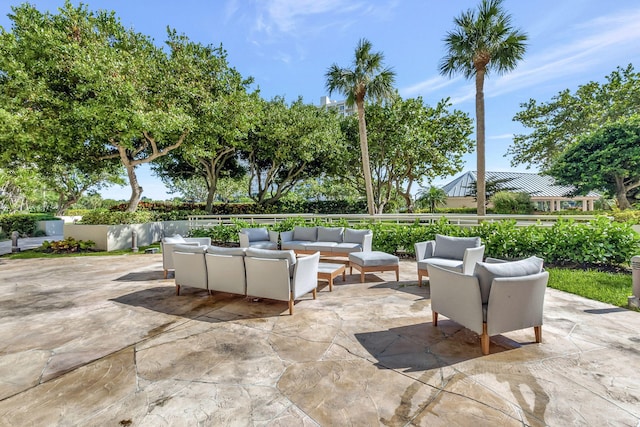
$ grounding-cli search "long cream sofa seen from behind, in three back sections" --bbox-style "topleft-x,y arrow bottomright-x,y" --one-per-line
173,245 -> 320,314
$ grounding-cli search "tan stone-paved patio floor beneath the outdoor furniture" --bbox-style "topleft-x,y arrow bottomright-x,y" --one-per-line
0,254 -> 640,426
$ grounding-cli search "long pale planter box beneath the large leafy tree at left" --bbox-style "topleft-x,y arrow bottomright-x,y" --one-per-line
64,222 -> 163,251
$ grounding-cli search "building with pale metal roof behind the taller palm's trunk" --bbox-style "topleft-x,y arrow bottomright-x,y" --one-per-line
442,171 -> 601,212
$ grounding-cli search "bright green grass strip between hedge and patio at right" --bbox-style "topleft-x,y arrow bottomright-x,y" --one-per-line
548,268 -> 632,307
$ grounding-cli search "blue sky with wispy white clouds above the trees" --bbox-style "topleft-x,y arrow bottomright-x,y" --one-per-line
0,0 -> 640,199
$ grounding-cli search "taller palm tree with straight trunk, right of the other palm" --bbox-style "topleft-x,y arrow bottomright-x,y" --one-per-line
440,0 -> 527,215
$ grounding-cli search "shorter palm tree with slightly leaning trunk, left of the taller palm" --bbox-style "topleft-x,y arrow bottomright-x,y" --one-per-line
325,39 -> 396,215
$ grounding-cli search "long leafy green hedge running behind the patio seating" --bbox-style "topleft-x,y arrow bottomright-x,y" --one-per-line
192,217 -> 640,266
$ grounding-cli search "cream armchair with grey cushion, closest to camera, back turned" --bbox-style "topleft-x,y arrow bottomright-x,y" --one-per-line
429,257 -> 549,355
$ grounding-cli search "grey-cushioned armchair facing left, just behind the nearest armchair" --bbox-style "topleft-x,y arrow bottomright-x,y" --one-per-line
415,234 -> 484,286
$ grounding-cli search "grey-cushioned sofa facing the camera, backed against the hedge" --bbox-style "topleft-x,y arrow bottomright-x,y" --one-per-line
280,227 -> 373,257
